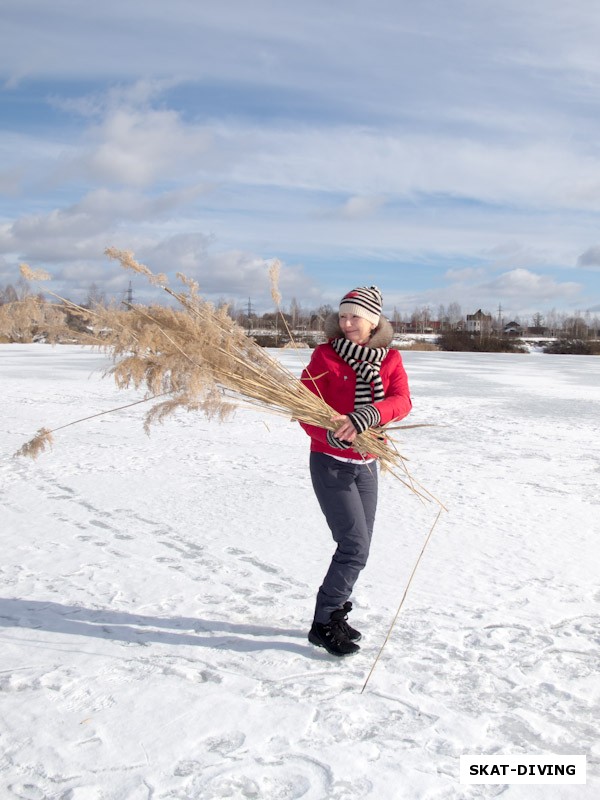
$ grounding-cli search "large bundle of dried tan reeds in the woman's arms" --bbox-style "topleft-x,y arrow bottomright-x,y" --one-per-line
19,248 -> 430,497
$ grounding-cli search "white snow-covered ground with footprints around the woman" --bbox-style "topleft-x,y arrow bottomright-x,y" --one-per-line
0,345 -> 600,800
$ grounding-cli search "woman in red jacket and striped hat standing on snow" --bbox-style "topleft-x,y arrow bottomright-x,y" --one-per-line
301,286 -> 411,656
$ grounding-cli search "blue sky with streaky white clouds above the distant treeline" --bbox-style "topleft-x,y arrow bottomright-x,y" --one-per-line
0,0 -> 600,318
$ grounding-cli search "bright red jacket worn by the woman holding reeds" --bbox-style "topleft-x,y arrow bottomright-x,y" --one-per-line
300,343 -> 412,460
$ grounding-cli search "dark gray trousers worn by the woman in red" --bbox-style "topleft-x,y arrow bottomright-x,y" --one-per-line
310,453 -> 378,623
